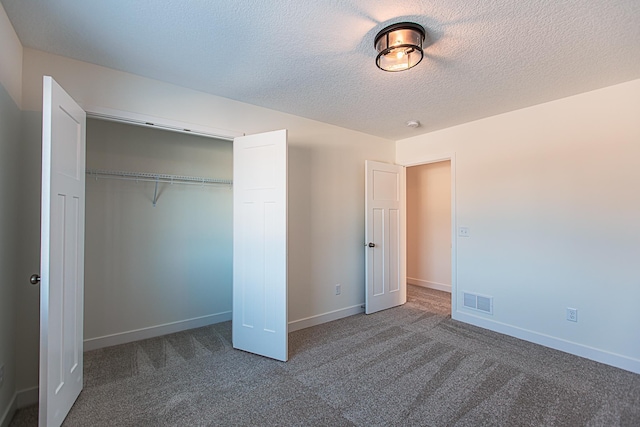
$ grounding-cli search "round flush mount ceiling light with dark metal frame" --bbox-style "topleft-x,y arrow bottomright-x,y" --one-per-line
374,22 -> 425,71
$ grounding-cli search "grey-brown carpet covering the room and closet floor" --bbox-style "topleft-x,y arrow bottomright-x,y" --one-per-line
12,286 -> 640,427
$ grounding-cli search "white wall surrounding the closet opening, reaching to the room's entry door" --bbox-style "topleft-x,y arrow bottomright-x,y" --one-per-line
18,49 -> 395,388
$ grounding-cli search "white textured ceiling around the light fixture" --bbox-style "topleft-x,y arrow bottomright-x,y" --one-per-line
0,0 -> 640,140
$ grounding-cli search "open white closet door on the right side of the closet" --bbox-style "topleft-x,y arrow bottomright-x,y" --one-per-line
232,130 -> 288,361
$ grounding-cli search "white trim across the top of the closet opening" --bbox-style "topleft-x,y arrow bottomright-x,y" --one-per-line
83,106 -> 244,141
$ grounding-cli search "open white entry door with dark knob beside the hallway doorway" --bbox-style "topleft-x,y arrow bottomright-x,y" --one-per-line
365,160 -> 407,314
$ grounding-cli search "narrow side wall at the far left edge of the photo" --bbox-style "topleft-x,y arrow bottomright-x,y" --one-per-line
0,5 -> 21,425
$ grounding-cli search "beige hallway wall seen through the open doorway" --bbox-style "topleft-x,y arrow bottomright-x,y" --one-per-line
407,160 -> 451,292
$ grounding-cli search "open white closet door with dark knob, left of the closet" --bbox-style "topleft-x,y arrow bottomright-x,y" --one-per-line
39,76 -> 85,427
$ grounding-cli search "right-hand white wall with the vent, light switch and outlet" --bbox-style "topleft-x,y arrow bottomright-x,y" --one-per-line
396,80 -> 640,373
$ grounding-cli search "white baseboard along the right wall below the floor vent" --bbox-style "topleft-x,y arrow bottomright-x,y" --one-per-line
451,311 -> 640,374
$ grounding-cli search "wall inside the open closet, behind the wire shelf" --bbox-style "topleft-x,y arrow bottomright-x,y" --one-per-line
84,119 -> 233,348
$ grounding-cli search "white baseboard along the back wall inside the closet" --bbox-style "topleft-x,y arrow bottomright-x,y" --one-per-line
84,311 -> 231,351
